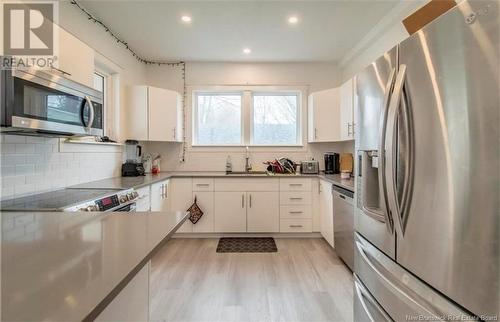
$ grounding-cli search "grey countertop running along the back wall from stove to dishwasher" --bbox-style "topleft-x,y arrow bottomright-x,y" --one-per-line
70,171 -> 354,192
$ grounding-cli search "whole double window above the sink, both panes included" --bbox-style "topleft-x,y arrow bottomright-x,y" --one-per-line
192,86 -> 302,146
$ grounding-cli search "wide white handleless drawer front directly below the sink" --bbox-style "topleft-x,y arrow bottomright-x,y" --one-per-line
215,178 -> 280,191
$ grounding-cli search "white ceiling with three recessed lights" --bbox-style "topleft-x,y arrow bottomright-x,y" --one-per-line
79,0 -> 401,62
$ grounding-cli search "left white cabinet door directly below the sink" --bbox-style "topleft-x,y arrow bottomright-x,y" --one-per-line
215,191 -> 247,233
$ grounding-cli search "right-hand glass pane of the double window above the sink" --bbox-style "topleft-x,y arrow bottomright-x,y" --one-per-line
252,94 -> 299,145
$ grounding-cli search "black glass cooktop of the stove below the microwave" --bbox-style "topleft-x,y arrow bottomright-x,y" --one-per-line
0,189 -> 121,211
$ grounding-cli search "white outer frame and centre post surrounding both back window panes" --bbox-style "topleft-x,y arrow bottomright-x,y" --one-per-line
187,85 -> 308,147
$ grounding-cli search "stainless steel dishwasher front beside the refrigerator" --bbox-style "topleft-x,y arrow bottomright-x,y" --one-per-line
332,185 -> 354,271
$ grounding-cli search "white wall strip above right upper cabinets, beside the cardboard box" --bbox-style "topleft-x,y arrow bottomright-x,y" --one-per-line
339,0 -> 428,81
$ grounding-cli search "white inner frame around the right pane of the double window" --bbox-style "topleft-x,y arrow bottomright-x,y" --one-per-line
248,90 -> 303,147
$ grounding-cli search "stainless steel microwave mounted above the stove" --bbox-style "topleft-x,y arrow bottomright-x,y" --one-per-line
0,70 -> 104,136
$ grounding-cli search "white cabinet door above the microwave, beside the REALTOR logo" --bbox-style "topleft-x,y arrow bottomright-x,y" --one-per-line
57,25 -> 95,88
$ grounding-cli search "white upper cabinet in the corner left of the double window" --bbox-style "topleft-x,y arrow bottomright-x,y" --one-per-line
126,86 -> 183,142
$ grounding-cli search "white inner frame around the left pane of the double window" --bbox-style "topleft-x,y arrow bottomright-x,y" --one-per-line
191,90 -> 245,147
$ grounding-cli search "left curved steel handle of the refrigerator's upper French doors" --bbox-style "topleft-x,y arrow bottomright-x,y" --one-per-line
378,67 -> 396,234
